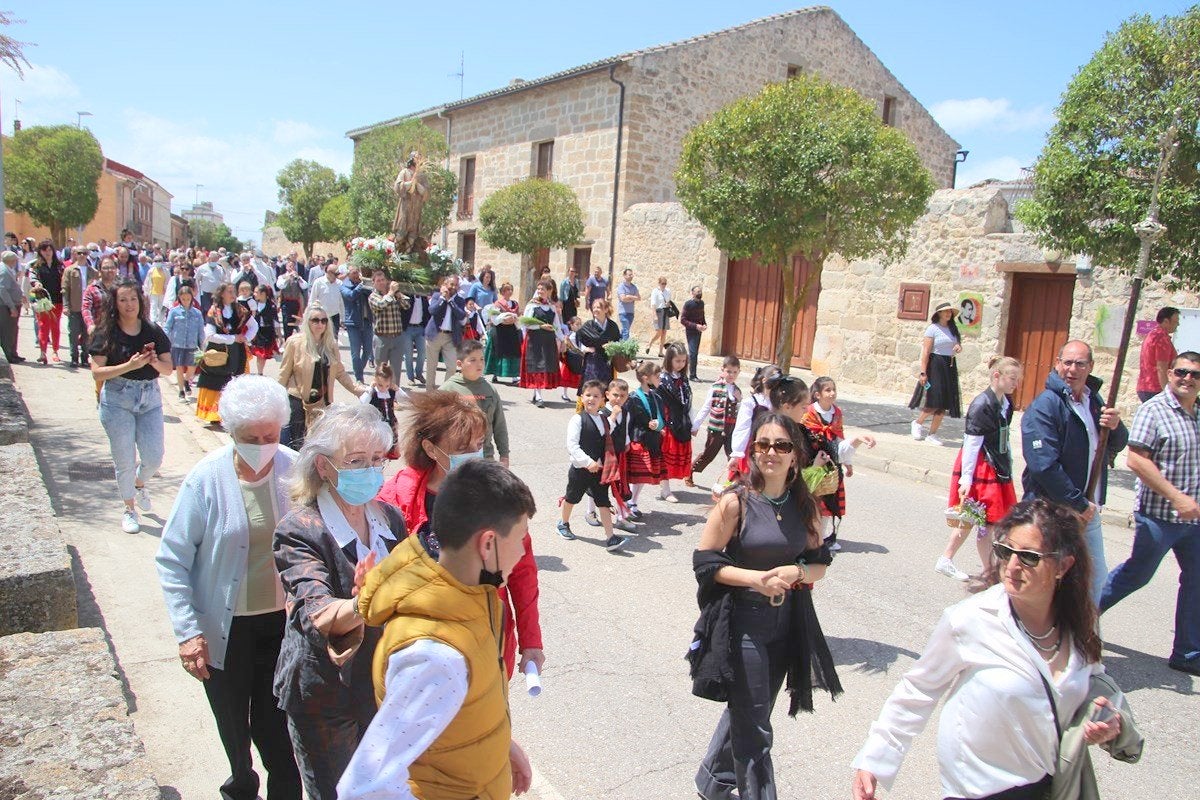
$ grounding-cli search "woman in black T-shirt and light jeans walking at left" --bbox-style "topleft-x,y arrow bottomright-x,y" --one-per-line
88,281 -> 172,534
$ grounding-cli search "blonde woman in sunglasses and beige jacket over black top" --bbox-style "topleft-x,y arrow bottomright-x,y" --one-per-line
278,302 -> 368,450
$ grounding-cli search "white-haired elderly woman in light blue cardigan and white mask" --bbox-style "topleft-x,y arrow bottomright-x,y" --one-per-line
156,375 -> 301,800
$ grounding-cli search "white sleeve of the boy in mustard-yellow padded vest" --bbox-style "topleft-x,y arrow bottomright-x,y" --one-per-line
337,639 -> 467,800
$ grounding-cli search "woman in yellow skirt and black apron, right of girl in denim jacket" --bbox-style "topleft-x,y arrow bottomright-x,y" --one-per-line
196,283 -> 258,426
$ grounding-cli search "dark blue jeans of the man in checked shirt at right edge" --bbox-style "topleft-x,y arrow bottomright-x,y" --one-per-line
1100,513 -> 1200,661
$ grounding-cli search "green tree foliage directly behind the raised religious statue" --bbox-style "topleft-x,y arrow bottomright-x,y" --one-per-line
350,119 -> 457,237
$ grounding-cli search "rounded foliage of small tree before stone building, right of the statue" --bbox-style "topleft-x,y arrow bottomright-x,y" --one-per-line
479,178 -> 583,287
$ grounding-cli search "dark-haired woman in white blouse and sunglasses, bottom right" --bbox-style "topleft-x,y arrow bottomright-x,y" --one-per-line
853,500 -> 1141,800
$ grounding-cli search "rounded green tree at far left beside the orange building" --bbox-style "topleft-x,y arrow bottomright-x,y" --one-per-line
4,125 -> 104,246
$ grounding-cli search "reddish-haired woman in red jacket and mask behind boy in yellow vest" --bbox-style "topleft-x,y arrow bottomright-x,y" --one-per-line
376,392 -> 545,678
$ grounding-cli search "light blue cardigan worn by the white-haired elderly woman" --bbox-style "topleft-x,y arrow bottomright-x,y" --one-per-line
155,445 -> 296,669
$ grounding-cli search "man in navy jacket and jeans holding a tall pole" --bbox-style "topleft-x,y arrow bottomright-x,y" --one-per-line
1021,339 -> 1129,603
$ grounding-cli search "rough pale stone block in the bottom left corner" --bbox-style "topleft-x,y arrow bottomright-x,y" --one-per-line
0,627 -> 161,800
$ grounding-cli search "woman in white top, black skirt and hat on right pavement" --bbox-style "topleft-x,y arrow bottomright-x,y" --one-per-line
908,302 -> 962,447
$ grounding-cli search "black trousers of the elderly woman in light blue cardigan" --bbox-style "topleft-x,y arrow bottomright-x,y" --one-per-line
204,610 -> 301,800
